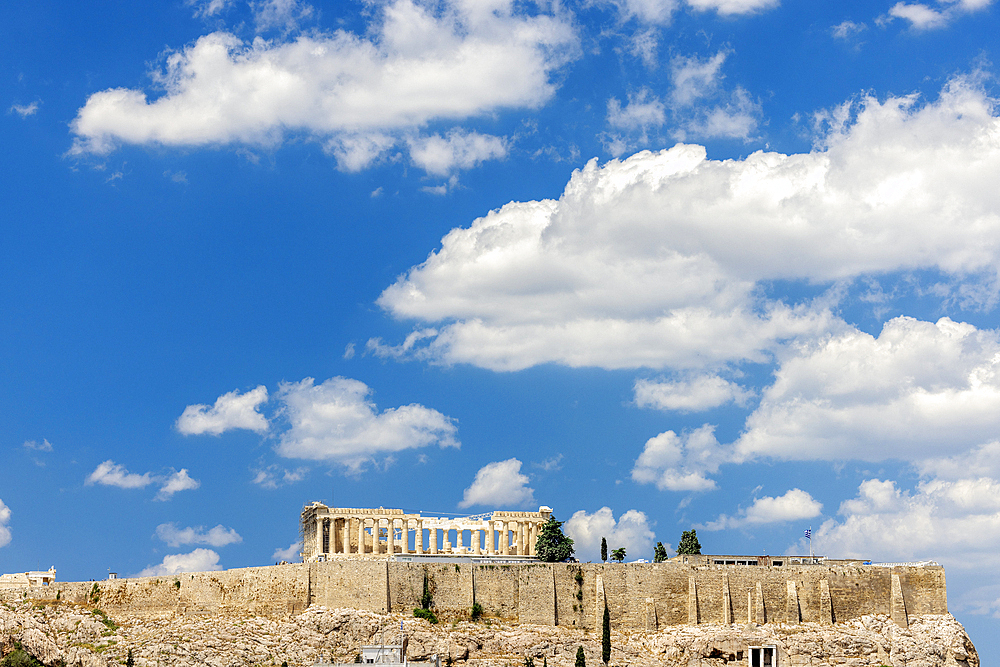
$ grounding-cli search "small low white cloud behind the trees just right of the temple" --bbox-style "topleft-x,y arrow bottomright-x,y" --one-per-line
563,507 -> 670,561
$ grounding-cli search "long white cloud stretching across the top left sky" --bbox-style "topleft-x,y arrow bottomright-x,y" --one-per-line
71,0 -> 578,171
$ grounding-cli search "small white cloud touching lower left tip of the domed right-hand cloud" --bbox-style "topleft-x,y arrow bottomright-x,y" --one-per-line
632,424 -> 732,491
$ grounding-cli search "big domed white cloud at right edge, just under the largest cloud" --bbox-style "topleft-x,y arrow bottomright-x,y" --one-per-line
736,317 -> 1000,461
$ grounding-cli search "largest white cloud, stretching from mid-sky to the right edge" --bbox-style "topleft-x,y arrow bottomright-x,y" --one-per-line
376,78 -> 1000,370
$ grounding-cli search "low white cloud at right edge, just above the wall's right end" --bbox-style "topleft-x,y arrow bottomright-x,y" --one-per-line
800,475 -> 1000,570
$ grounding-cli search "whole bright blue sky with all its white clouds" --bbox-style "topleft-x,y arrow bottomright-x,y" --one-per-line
0,0 -> 1000,655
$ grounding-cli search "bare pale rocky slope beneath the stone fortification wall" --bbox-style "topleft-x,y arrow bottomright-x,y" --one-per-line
0,601 -> 979,667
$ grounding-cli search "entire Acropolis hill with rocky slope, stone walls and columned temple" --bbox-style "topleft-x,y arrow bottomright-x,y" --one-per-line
0,503 -> 979,667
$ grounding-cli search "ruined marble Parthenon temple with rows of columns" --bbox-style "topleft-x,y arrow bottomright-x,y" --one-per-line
301,502 -> 552,562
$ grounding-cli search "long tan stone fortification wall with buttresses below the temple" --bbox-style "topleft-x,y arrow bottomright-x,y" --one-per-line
0,559 -> 948,629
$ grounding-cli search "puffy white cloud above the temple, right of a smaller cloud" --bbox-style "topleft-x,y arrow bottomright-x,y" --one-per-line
276,377 -> 459,471
